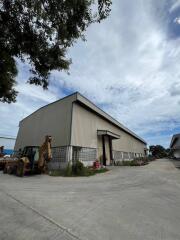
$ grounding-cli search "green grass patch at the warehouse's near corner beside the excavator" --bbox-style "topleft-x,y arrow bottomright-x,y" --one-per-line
49,161 -> 109,177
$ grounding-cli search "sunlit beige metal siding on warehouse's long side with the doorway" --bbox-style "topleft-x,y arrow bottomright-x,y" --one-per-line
71,103 -> 146,154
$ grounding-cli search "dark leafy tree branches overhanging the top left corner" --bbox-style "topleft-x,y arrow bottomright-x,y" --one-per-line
0,0 -> 111,103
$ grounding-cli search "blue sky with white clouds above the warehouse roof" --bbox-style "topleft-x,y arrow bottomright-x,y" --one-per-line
0,0 -> 180,147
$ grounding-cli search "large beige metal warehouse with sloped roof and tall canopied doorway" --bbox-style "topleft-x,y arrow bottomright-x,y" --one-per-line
15,92 -> 146,168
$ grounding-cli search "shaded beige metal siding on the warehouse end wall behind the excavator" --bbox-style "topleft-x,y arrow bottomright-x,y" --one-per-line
15,96 -> 74,150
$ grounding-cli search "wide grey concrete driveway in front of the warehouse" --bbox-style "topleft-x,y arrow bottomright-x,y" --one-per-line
0,159 -> 180,240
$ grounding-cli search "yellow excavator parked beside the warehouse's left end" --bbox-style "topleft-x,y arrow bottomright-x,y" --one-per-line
3,136 -> 52,177
